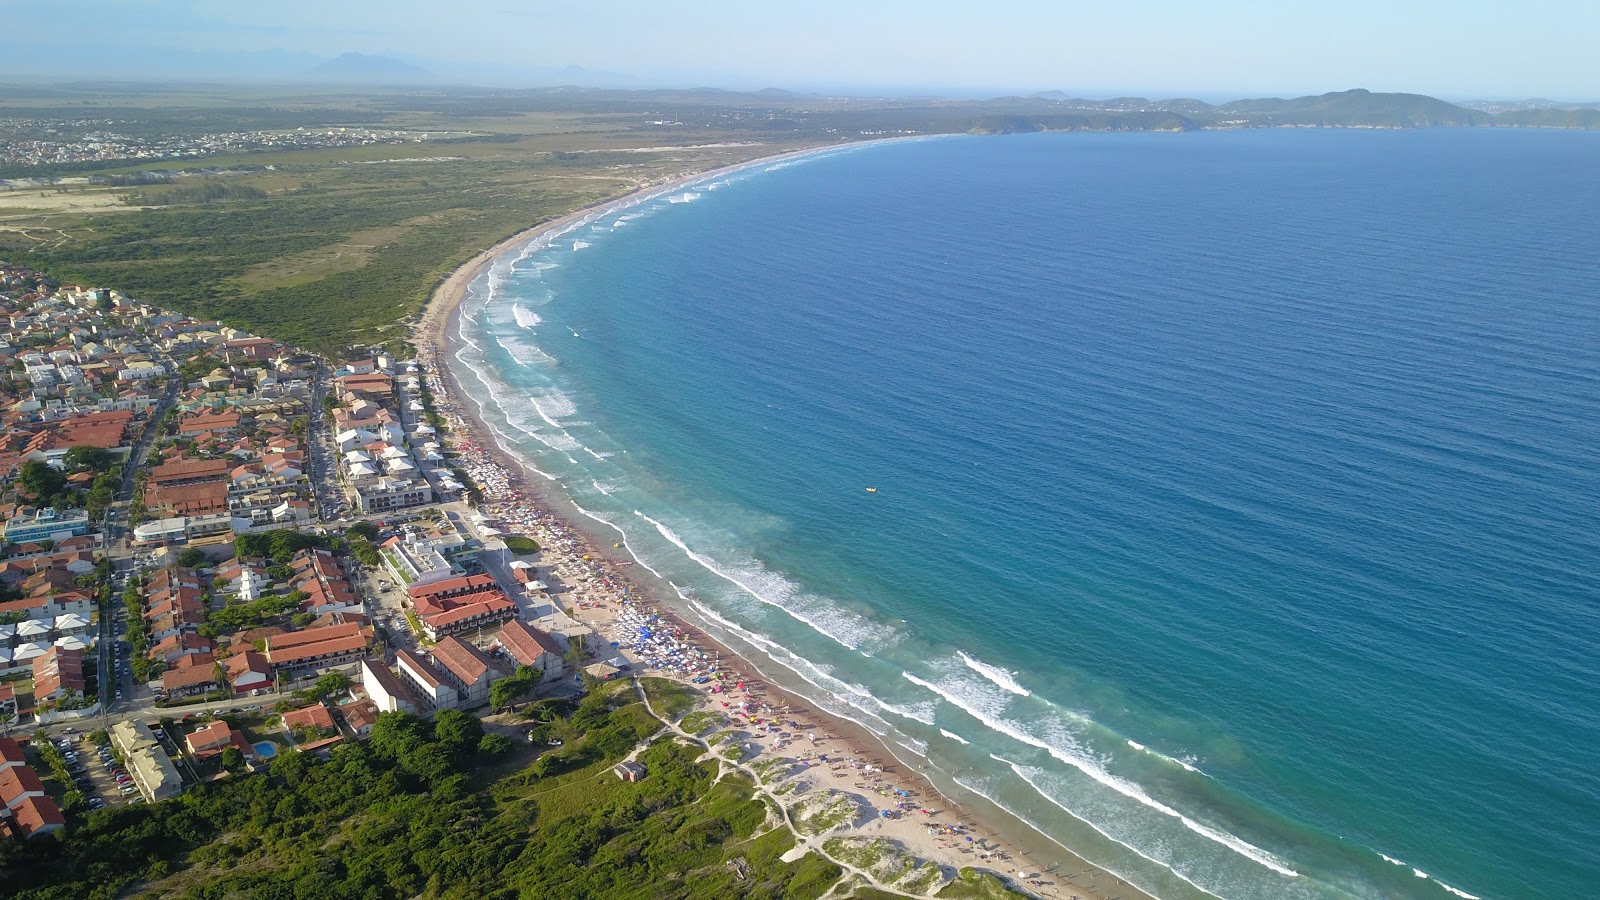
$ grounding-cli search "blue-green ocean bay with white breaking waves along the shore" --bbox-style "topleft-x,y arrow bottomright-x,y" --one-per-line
451,130 -> 1600,900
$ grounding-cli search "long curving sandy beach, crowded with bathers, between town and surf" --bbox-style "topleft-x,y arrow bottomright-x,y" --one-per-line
413,151 -> 1146,900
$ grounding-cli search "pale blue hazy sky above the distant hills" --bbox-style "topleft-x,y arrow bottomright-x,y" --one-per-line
12,0 -> 1600,99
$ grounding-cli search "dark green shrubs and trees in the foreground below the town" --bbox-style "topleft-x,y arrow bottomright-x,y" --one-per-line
0,679 -> 842,900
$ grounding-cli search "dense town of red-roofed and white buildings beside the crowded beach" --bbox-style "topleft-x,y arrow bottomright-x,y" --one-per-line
0,257 -> 581,838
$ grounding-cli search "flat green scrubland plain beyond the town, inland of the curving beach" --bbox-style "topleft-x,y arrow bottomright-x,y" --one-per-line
0,88 -> 837,352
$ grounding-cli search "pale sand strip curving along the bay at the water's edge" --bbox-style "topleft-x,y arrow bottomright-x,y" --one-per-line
413,144 -> 1147,900
